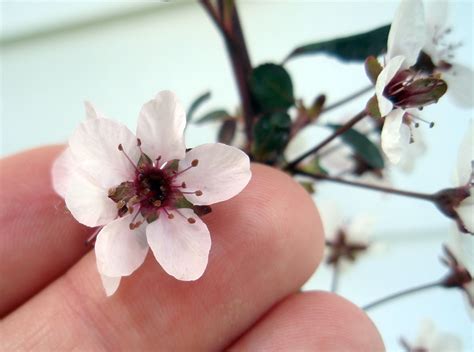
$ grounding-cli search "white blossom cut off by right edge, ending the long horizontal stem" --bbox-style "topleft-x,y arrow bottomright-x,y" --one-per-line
435,121 -> 474,234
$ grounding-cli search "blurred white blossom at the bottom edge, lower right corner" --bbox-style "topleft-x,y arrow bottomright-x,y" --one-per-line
400,319 -> 462,352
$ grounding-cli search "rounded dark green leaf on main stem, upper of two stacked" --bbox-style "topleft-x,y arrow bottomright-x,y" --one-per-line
249,64 -> 295,113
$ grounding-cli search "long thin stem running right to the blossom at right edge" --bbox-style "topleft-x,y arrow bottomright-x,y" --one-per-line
292,169 -> 434,202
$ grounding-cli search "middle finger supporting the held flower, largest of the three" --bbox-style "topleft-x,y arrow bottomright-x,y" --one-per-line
4,165 -> 323,350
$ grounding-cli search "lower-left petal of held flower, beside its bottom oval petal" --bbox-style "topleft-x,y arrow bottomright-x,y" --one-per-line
95,215 -> 148,277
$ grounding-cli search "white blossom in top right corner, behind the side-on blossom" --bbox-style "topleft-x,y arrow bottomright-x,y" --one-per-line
415,0 -> 474,108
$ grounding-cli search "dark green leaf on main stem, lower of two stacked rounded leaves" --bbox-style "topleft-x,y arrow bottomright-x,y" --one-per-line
252,112 -> 291,164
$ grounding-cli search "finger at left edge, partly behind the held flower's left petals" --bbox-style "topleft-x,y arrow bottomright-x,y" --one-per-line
0,146 -> 91,317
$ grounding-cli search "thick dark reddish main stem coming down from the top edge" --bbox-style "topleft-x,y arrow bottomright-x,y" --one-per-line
200,0 -> 255,143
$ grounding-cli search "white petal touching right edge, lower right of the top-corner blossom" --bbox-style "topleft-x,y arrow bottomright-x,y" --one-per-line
442,64 -> 474,109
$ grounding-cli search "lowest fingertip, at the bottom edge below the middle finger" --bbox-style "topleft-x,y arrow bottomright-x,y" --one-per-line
230,292 -> 384,352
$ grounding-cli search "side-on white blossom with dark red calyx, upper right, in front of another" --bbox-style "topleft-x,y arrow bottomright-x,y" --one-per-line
375,0 -> 447,164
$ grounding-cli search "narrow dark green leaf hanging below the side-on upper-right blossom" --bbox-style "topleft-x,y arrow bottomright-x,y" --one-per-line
329,124 -> 385,169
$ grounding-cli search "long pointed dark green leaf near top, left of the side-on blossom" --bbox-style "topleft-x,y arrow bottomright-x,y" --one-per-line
285,25 -> 390,61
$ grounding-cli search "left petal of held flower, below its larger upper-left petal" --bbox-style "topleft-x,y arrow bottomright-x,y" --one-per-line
65,170 -> 117,227
